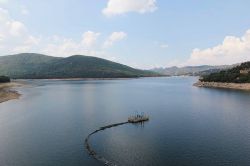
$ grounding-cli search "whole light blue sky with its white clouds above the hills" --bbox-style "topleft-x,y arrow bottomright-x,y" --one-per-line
0,0 -> 250,69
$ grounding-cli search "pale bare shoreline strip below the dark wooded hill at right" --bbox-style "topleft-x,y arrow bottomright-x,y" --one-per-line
193,81 -> 250,91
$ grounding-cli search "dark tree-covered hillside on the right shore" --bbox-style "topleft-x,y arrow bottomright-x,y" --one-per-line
200,62 -> 250,83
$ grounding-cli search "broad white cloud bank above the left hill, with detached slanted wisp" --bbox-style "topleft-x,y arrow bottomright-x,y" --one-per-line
0,8 -> 126,60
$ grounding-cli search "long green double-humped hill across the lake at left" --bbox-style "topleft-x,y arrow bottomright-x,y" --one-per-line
0,53 -> 158,79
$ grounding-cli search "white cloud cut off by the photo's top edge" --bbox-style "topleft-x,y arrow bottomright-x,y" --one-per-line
102,0 -> 157,16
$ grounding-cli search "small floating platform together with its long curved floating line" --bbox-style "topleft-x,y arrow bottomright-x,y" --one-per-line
85,114 -> 149,166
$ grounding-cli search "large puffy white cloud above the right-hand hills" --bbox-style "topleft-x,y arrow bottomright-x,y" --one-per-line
185,30 -> 250,65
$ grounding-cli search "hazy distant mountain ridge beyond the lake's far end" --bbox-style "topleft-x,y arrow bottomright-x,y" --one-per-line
151,65 -> 235,76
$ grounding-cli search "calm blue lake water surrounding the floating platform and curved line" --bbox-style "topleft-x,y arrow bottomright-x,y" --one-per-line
0,77 -> 250,166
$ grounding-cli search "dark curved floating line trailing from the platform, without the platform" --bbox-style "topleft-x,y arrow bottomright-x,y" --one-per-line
84,122 -> 129,166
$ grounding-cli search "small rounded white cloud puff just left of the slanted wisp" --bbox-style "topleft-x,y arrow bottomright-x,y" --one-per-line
82,31 -> 100,47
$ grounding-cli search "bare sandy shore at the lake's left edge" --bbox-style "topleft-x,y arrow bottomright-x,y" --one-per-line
0,81 -> 22,103
